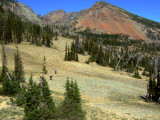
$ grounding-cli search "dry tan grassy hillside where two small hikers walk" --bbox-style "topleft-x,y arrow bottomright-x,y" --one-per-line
0,38 -> 160,120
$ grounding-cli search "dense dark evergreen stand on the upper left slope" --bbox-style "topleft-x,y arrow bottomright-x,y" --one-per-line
0,4 -> 58,47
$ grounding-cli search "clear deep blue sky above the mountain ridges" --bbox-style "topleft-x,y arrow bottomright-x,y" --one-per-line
18,0 -> 160,22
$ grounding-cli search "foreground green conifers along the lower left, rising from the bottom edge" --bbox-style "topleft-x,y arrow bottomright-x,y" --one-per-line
0,46 -> 85,120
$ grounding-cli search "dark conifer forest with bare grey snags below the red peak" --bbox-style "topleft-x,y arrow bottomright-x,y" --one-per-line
62,28 -> 160,101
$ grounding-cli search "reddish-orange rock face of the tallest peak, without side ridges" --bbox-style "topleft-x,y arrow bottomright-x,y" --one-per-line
76,3 -> 146,40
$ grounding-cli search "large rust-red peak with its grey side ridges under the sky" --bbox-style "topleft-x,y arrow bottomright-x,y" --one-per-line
45,1 -> 160,40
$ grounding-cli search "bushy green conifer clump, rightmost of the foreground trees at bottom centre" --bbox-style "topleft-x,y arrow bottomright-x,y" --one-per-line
62,78 -> 85,120
